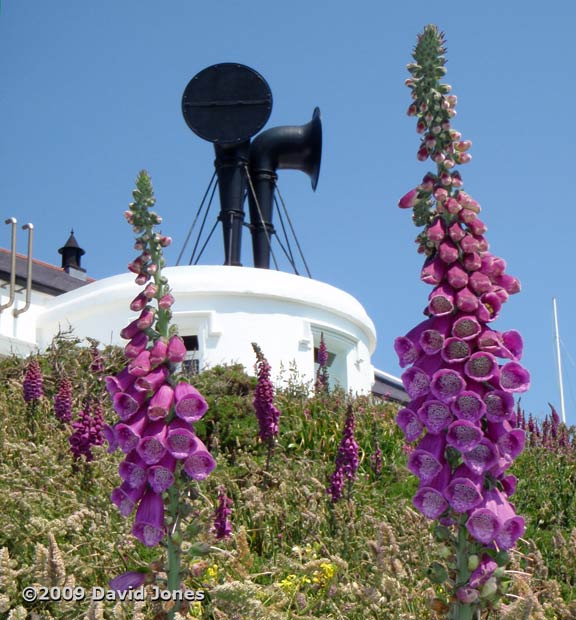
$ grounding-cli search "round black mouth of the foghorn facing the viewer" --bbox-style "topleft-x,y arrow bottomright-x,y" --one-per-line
182,62 -> 272,144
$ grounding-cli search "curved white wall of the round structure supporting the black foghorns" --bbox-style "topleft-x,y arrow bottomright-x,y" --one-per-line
37,265 -> 376,393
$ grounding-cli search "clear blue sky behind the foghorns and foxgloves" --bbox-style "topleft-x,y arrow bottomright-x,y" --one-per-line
0,0 -> 576,423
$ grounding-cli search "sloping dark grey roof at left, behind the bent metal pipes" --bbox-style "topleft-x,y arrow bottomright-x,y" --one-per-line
0,248 -> 94,295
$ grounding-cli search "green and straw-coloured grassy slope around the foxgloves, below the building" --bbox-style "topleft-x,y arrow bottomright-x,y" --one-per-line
0,335 -> 576,620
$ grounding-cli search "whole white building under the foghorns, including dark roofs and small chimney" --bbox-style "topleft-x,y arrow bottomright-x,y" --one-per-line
0,234 -> 404,400
